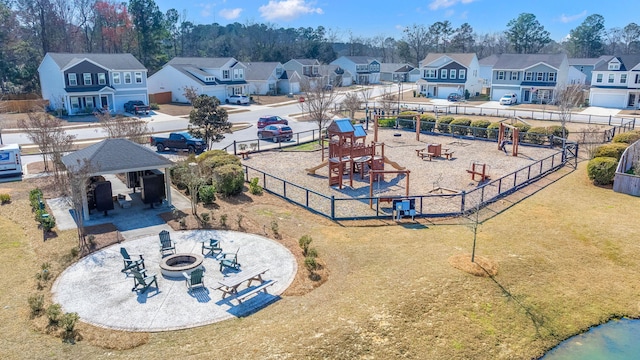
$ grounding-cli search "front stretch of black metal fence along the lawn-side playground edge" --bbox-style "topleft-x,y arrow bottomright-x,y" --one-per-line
243,139 -> 578,220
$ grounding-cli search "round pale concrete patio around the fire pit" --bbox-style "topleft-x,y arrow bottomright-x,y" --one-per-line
52,230 -> 297,332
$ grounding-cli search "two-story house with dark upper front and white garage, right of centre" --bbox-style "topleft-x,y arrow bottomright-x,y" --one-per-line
416,53 -> 482,99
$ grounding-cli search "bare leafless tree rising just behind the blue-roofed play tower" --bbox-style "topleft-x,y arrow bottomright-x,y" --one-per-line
301,77 -> 337,143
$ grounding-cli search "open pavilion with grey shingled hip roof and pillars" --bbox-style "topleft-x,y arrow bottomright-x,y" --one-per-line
62,139 -> 174,219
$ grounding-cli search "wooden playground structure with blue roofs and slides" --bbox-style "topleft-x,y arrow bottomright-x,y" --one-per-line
306,119 -> 407,189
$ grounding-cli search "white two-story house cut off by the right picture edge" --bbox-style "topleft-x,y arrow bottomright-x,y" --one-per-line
589,55 -> 640,109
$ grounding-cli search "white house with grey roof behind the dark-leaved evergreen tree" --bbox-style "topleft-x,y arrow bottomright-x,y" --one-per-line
148,57 -> 249,103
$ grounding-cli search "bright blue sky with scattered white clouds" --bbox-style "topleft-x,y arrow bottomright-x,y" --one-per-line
156,0 -> 640,41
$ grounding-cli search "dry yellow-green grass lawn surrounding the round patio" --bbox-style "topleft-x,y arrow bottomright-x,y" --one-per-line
0,158 -> 640,359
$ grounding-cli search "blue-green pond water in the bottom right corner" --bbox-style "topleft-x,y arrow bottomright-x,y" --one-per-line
541,319 -> 640,360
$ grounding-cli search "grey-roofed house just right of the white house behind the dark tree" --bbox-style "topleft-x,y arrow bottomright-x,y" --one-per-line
244,62 -> 289,95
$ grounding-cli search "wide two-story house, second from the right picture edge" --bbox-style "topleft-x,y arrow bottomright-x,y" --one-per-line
491,54 -> 569,103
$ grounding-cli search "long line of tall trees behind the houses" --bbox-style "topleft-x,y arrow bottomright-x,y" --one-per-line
0,0 -> 640,93
